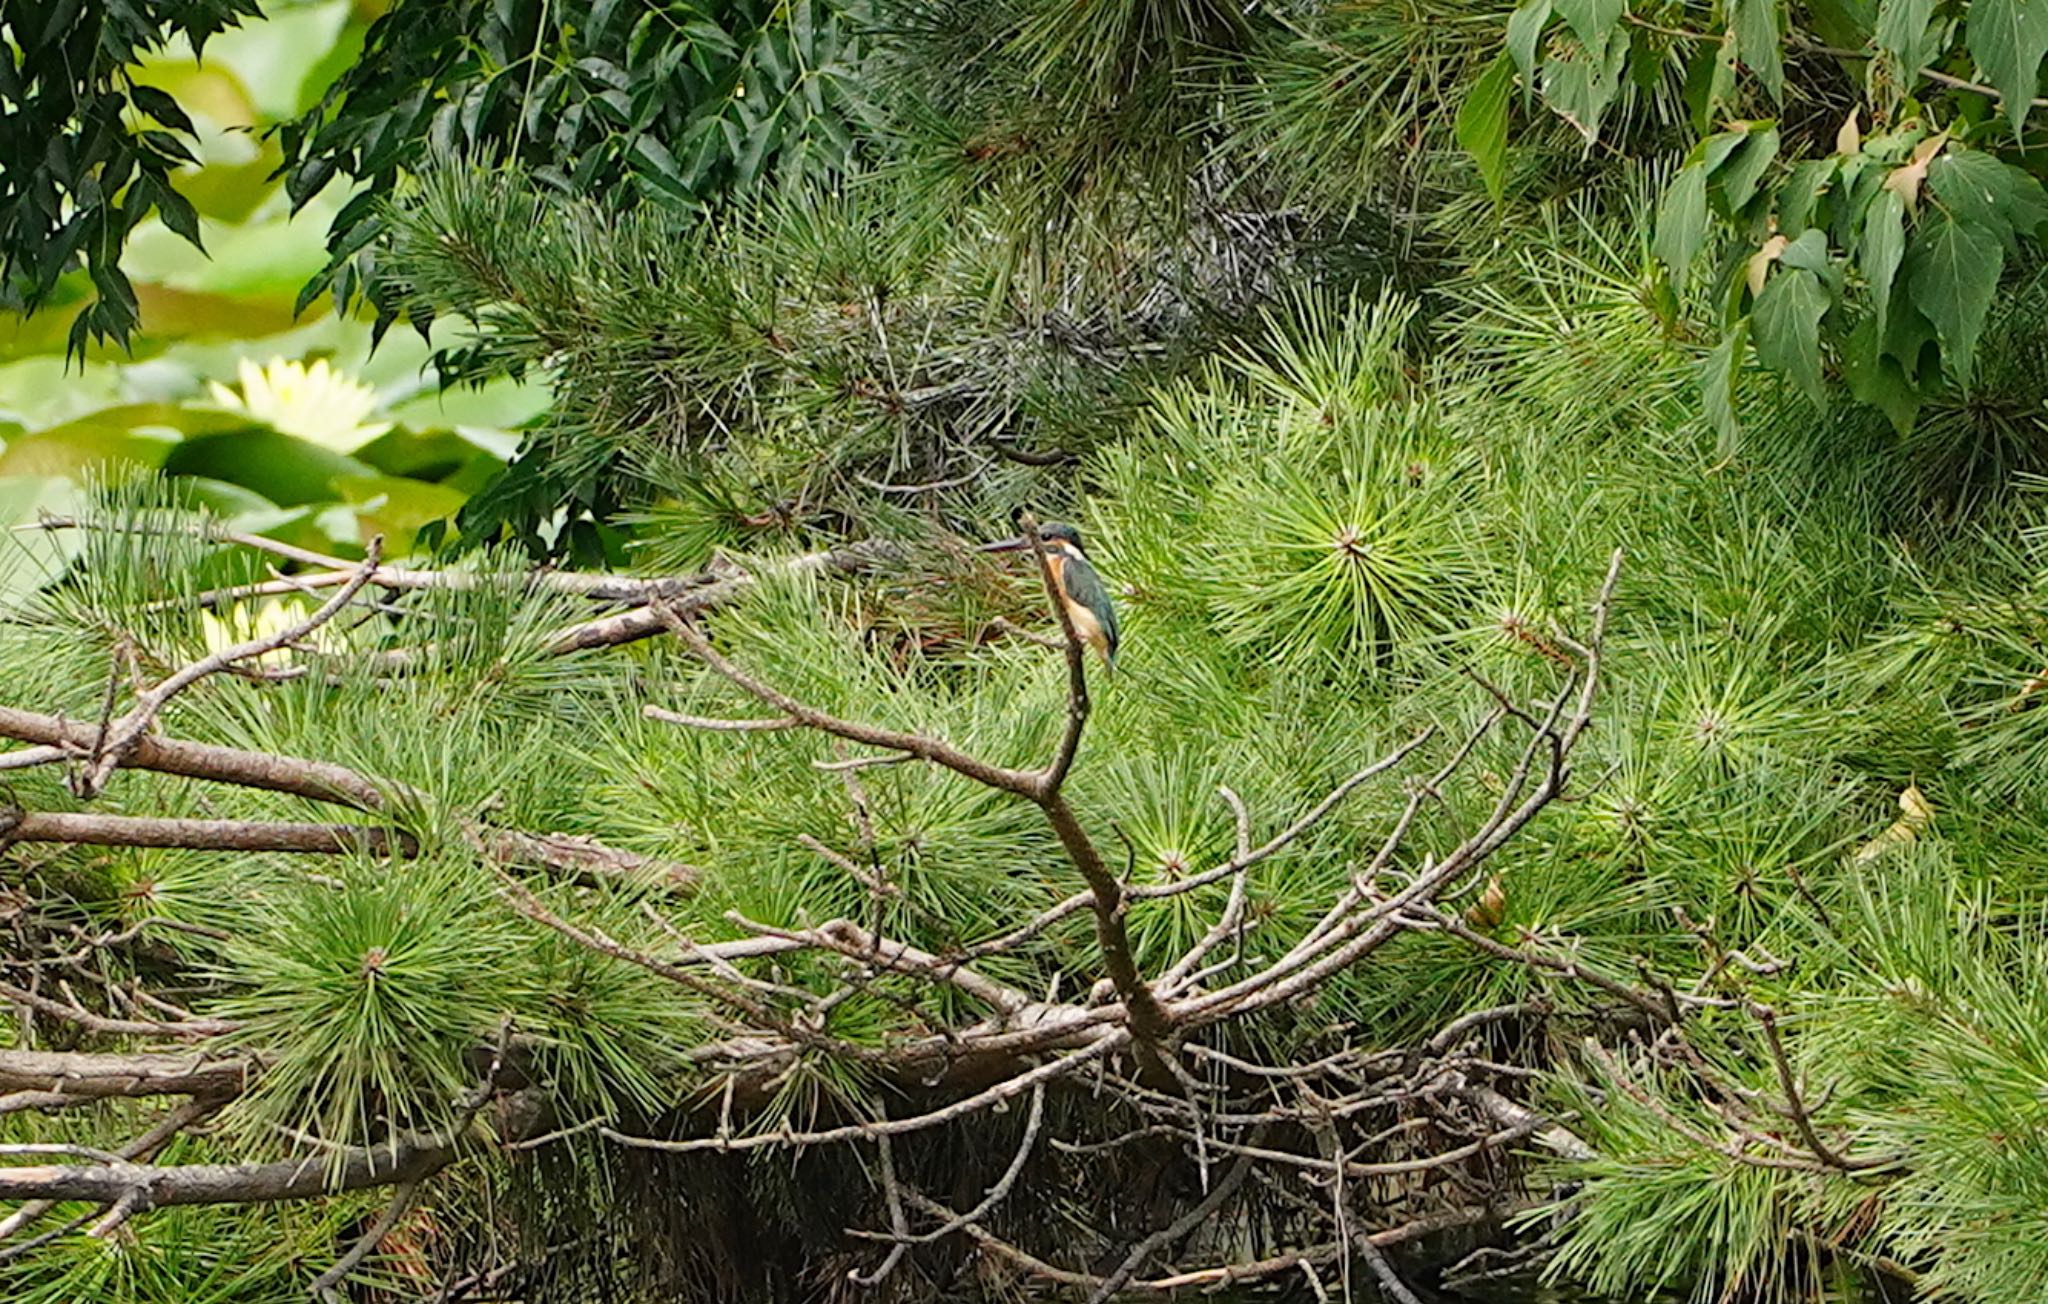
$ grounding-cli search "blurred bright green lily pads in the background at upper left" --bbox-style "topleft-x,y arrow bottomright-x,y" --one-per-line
0,0 -> 547,596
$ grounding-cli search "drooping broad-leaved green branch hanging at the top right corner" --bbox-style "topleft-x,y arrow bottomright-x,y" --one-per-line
1482,0 -> 2048,440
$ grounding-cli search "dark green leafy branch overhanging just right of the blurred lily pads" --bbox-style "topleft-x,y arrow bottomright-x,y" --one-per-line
279,0 -> 870,328
